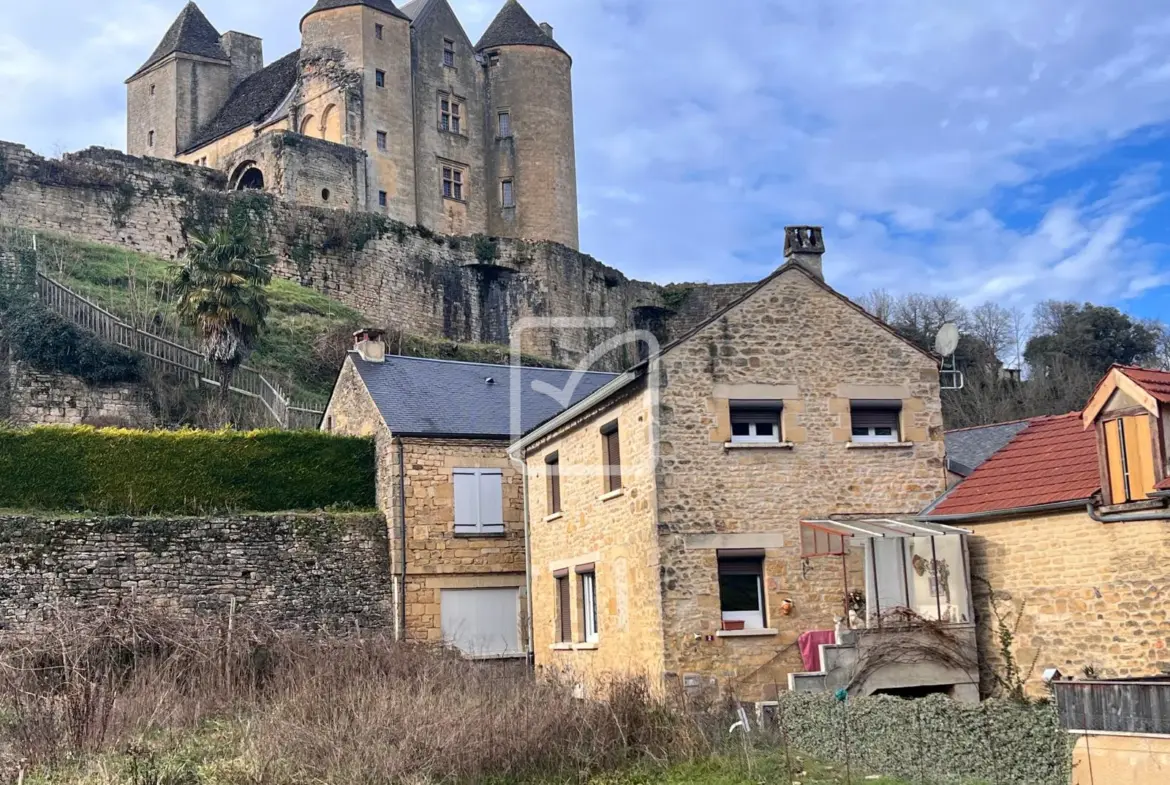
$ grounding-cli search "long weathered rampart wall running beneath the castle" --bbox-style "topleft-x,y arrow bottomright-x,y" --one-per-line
0,143 -> 742,370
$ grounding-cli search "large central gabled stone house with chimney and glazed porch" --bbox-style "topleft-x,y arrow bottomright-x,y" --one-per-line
510,227 -> 976,700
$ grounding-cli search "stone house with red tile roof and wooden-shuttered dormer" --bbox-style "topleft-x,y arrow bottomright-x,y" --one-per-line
923,366 -> 1170,694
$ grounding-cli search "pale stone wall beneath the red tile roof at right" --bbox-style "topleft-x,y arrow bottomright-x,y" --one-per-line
963,511 -> 1170,695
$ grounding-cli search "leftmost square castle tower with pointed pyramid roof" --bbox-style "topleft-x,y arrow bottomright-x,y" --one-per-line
126,2 -> 234,159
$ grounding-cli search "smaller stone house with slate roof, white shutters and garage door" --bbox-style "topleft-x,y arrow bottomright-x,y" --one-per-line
322,331 -> 613,657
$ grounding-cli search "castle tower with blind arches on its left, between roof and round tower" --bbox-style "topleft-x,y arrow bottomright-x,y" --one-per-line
299,0 -> 417,223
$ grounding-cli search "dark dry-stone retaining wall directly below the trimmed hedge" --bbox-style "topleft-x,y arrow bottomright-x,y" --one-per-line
0,514 -> 393,629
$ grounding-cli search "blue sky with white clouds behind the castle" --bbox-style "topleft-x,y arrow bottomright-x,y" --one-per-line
0,0 -> 1170,319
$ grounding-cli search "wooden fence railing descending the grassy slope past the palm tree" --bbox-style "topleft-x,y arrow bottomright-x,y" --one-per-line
36,271 -> 324,429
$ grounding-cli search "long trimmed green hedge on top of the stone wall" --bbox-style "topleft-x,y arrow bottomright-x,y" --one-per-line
0,426 -> 376,515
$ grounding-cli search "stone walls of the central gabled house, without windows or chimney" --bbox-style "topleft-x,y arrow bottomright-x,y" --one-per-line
527,266 -> 945,696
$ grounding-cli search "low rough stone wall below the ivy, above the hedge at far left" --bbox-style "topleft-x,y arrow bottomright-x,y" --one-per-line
0,363 -> 158,428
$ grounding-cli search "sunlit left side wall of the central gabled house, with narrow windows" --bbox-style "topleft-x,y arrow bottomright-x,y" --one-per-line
527,388 -> 663,684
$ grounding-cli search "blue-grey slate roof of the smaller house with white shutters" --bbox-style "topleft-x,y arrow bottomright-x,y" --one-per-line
350,352 -> 617,439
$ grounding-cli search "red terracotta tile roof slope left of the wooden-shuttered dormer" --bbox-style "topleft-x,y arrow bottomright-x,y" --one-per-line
927,412 -> 1101,518
